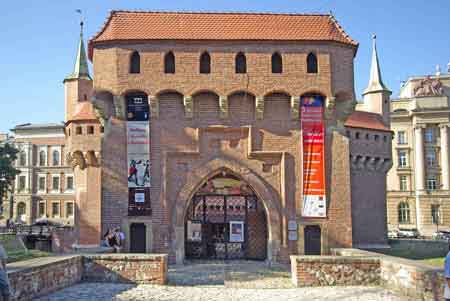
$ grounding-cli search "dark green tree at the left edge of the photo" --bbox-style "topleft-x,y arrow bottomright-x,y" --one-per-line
0,143 -> 20,207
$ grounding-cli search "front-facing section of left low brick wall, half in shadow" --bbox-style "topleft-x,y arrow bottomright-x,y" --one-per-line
83,254 -> 168,284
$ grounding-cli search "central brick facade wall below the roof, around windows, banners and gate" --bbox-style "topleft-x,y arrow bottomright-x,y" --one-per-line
86,41 -> 362,260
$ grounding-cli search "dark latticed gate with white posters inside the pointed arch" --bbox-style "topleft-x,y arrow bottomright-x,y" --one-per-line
184,171 -> 267,260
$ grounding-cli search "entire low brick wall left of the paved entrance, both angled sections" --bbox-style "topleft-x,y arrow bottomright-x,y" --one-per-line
7,254 -> 167,301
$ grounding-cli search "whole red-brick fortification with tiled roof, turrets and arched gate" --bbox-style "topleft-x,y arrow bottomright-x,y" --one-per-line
65,11 -> 392,262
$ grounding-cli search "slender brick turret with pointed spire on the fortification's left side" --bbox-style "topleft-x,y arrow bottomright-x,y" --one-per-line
64,22 -> 103,245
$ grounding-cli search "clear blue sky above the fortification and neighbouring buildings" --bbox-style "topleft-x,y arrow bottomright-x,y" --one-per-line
0,0 -> 450,132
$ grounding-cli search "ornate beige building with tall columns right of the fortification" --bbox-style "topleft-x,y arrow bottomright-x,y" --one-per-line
387,72 -> 450,236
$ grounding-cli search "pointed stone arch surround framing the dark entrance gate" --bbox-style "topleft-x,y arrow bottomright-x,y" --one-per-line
172,158 -> 281,263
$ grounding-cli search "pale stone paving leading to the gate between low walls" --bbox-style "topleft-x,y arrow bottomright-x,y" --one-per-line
36,261 -> 410,301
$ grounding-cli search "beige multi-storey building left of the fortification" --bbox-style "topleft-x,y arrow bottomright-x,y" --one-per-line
3,123 -> 75,224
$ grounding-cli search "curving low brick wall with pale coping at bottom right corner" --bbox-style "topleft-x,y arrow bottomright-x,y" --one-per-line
332,249 -> 445,300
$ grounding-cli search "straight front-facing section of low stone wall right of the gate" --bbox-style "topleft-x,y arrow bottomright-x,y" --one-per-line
291,256 -> 380,286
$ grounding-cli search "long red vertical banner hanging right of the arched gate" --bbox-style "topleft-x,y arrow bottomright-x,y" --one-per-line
300,95 -> 327,217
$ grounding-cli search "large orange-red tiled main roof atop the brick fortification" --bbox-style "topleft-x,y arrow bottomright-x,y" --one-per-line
89,11 -> 358,59
